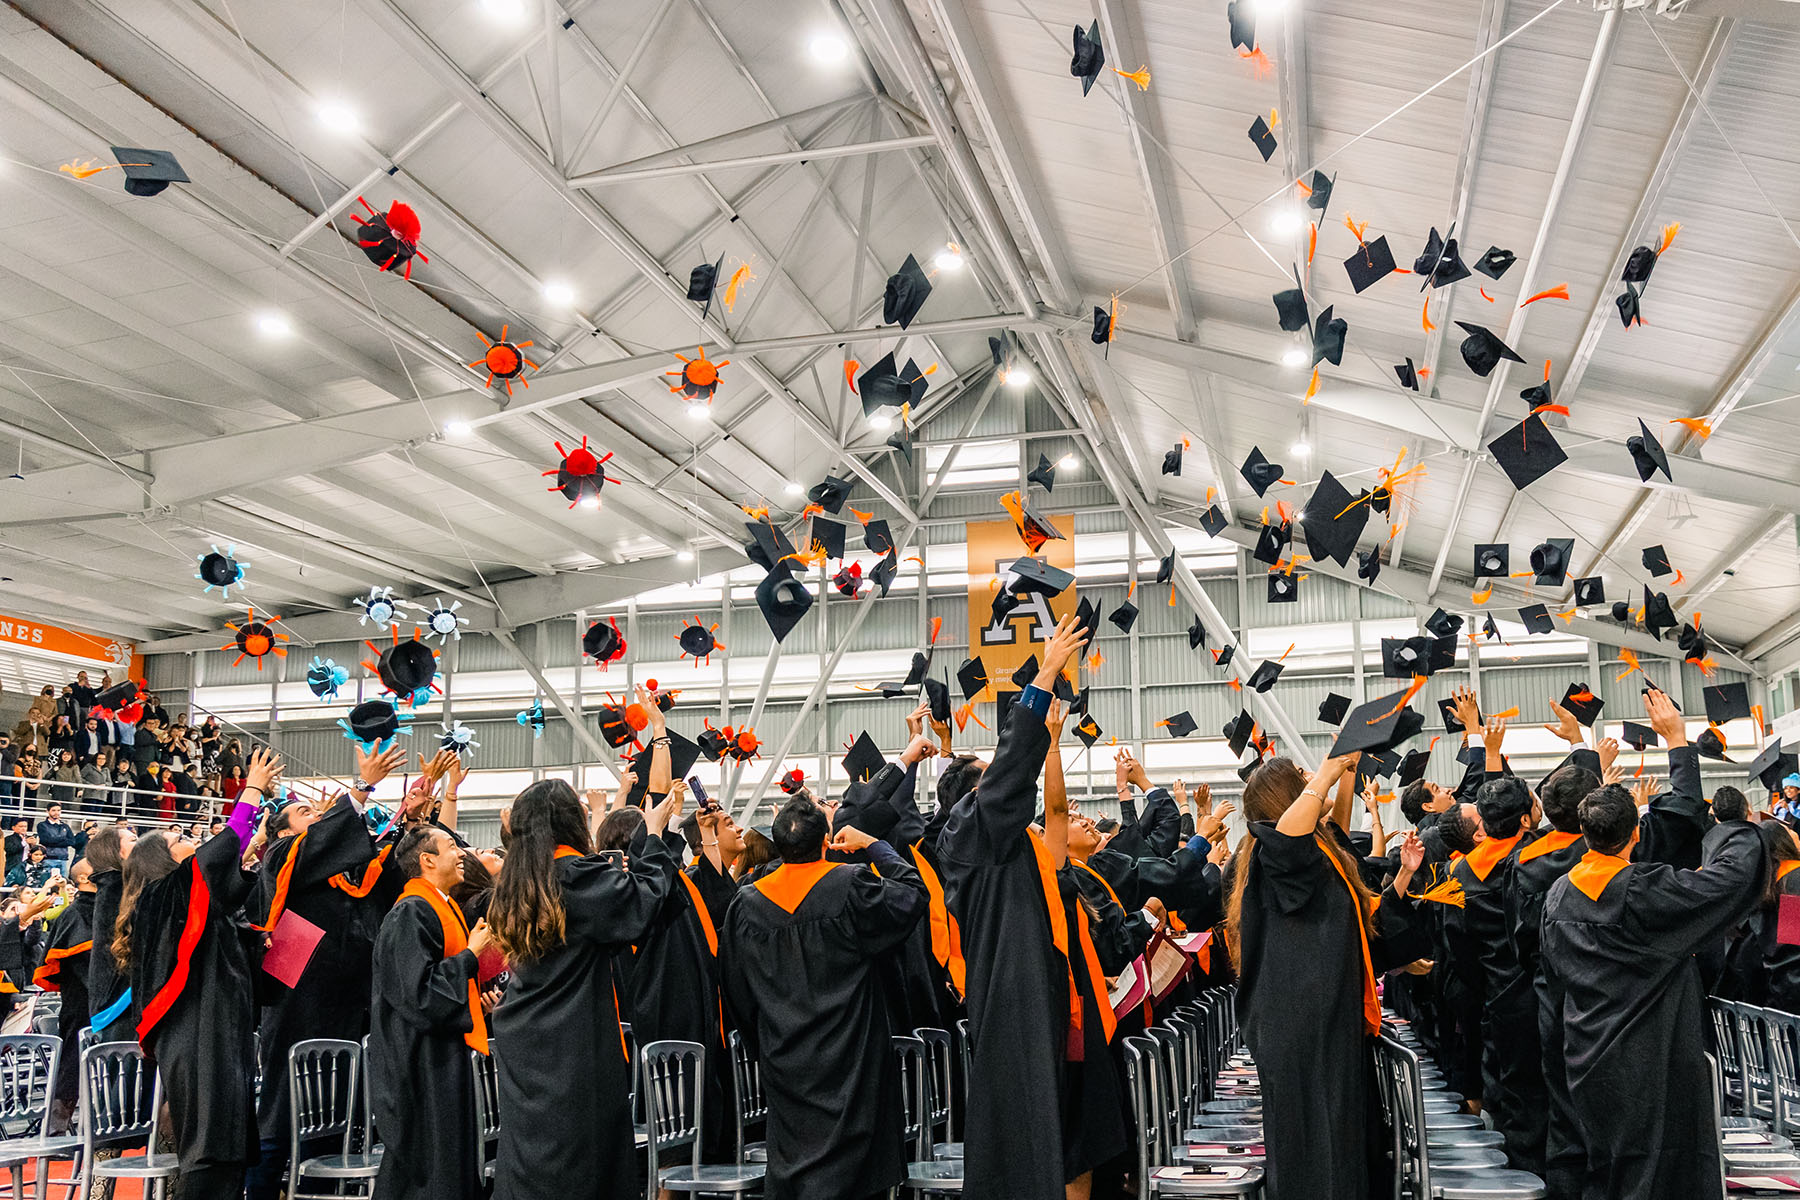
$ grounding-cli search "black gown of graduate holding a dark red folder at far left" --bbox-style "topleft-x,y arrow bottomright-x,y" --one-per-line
256,795 -> 383,1151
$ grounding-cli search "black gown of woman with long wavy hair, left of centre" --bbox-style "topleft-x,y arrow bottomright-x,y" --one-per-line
493,838 -> 680,1200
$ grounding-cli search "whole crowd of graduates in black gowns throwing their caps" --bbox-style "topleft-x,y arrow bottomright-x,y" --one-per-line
10,619 -> 1800,1200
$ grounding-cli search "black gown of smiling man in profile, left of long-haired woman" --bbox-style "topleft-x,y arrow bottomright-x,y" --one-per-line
369,896 -> 481,1200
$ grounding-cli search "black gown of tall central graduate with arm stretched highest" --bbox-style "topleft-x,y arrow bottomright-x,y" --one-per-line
938,703 -> 1069,1200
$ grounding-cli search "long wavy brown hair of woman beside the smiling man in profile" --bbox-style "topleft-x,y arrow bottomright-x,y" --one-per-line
488,779 -> 592,963
